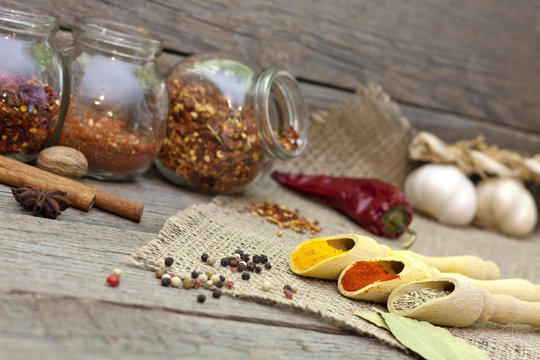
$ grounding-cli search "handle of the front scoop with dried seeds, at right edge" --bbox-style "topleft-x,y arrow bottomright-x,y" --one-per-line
489,295 -> 540,328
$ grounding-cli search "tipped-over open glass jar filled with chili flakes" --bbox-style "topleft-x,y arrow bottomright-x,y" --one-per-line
156,54 -> 308,193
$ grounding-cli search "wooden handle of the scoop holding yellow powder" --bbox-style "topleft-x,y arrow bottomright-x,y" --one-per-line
393,250 -> 499,280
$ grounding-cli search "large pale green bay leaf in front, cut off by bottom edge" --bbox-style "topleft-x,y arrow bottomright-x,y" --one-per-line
378,311 -> 489,360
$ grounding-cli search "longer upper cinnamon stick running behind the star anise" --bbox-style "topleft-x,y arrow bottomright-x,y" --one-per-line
0,155 -> 144,222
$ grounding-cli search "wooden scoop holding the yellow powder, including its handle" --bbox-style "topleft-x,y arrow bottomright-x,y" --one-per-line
289,234 -> 499,280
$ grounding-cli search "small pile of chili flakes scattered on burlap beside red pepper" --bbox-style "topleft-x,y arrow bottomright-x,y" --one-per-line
238,201 -> 322,235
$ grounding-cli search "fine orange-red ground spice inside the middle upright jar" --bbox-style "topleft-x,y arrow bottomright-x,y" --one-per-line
58,105 -> 161,174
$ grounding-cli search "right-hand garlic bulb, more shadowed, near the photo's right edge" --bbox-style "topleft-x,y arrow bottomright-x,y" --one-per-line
474,179 -> 538,237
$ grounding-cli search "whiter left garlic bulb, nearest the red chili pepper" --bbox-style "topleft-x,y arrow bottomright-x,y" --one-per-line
404,164 -> 477,226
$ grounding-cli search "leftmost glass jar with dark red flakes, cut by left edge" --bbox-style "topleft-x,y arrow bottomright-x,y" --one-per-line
0,1 -> 64,161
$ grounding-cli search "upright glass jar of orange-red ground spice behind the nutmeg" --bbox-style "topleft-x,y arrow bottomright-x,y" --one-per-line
58,18 -> 168,180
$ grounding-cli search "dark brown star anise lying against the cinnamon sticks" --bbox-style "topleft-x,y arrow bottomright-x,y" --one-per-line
11,186 -> 71,219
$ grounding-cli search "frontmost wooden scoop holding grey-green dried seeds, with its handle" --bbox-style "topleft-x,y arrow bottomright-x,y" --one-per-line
387,277 -> 540,327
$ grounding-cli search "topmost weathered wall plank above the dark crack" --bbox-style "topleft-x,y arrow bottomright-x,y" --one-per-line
30,0 -> 540,133
